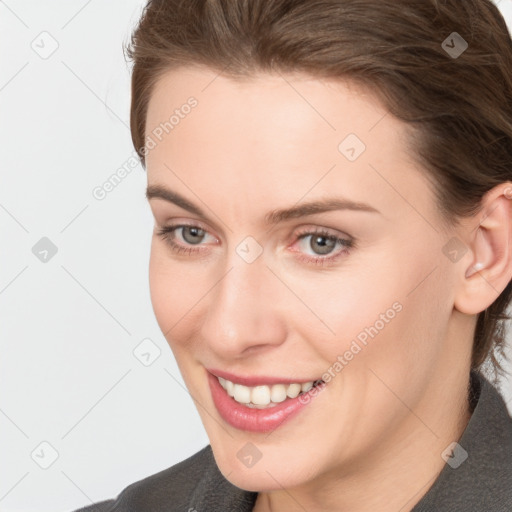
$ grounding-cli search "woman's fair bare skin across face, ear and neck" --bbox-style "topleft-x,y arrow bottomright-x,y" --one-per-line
146,67 -> 511,512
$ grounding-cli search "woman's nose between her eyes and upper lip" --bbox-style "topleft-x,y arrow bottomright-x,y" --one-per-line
200,249 -> 290,361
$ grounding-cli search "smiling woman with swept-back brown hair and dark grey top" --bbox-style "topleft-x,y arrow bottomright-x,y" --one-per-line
74,0 -> 512,512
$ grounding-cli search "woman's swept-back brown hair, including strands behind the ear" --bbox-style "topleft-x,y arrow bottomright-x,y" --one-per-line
125,0 -> 512,382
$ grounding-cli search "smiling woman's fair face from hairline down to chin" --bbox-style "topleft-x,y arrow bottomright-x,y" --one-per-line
146,68 -> 467,491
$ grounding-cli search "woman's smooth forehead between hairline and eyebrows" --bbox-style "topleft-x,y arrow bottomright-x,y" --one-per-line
146,67 -> 431,229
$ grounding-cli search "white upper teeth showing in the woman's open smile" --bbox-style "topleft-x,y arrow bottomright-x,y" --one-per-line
217,377 -> 322,408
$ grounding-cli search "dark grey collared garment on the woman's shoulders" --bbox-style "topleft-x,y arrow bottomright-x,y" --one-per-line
75,372 -> 512,512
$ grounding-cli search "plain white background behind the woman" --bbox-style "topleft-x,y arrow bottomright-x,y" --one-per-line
0,0 -> 512,512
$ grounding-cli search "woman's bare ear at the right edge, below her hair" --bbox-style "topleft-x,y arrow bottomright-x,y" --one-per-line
454,182 -> 512,315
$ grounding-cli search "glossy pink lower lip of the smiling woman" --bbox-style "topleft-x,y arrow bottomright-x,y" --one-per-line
207,372 -> 318,432
